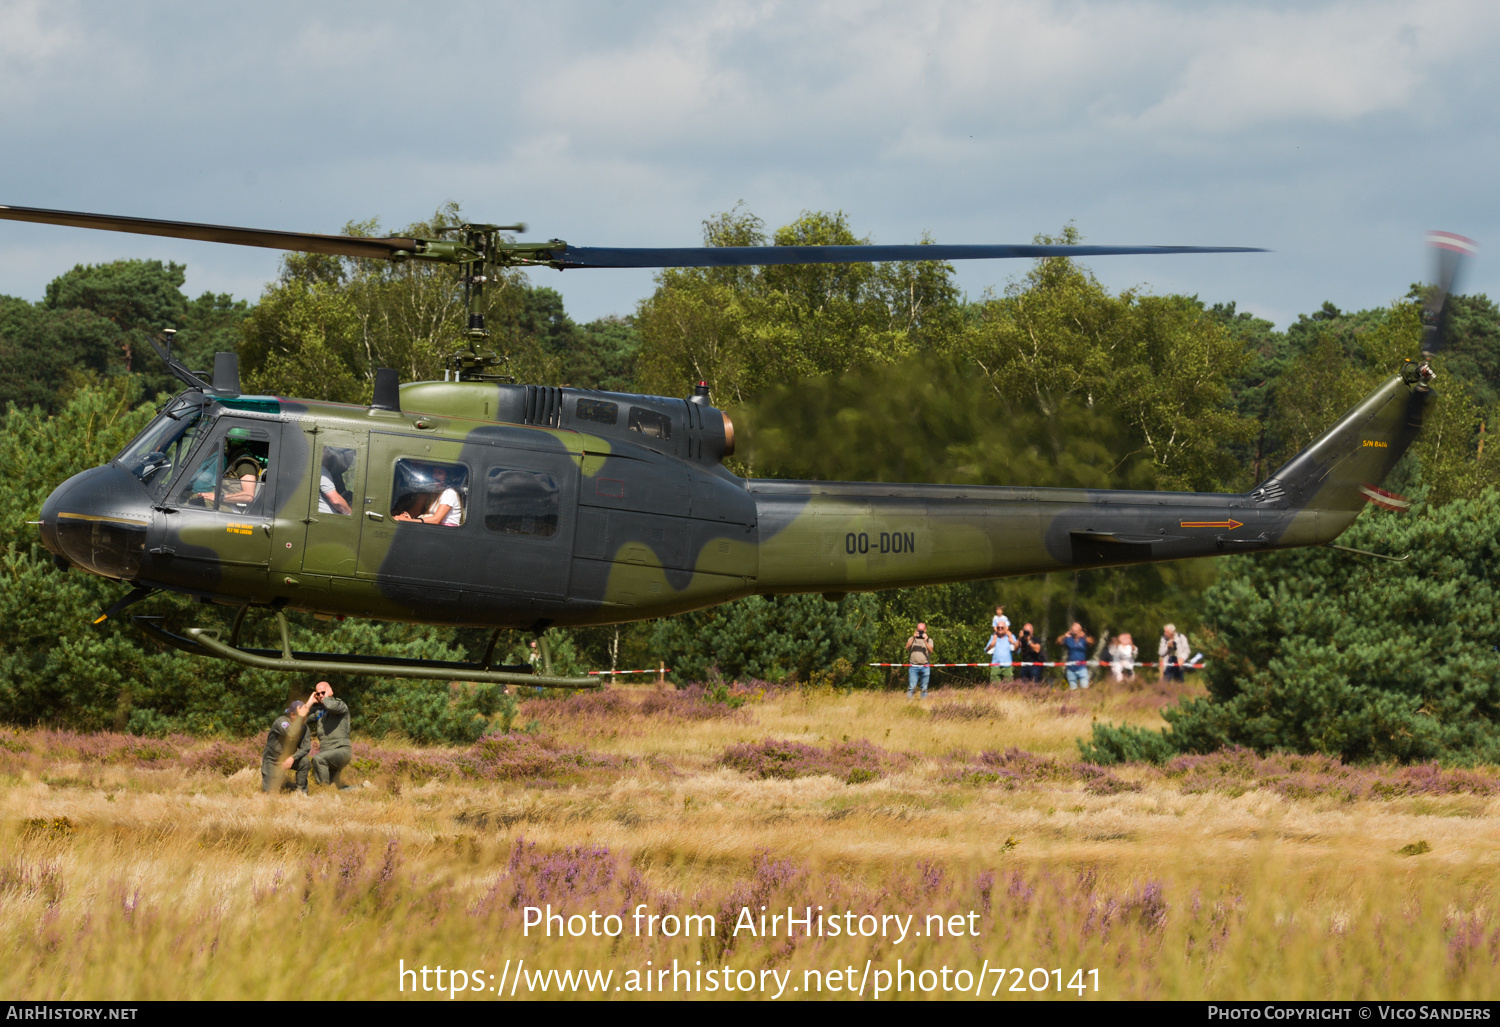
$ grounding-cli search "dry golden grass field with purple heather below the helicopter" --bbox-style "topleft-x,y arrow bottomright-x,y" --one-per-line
0,685 -> 1500,1002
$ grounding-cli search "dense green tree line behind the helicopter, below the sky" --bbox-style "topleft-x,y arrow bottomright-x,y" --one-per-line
0,204 -> 1500,759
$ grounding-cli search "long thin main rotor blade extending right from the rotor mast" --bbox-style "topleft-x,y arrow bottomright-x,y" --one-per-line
554,243 -> 1265,268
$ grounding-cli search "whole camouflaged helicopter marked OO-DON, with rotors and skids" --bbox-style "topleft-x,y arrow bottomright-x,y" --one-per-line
0,207 -> 1475,687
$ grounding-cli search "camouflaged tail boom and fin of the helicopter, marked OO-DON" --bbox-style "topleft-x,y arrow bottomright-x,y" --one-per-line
746,376 -> 1431,594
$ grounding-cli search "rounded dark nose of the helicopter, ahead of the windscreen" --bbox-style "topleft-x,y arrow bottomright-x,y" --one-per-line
42,463 -> 150,580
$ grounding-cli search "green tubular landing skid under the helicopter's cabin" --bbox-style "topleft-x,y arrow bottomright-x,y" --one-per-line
131,610 -> 600,688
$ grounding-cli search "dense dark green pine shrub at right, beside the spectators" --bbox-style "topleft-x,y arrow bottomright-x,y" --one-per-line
1080,492 -> 1500,763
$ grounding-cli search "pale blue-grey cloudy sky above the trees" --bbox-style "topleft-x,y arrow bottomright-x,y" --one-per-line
0,0 -> 1500,324
